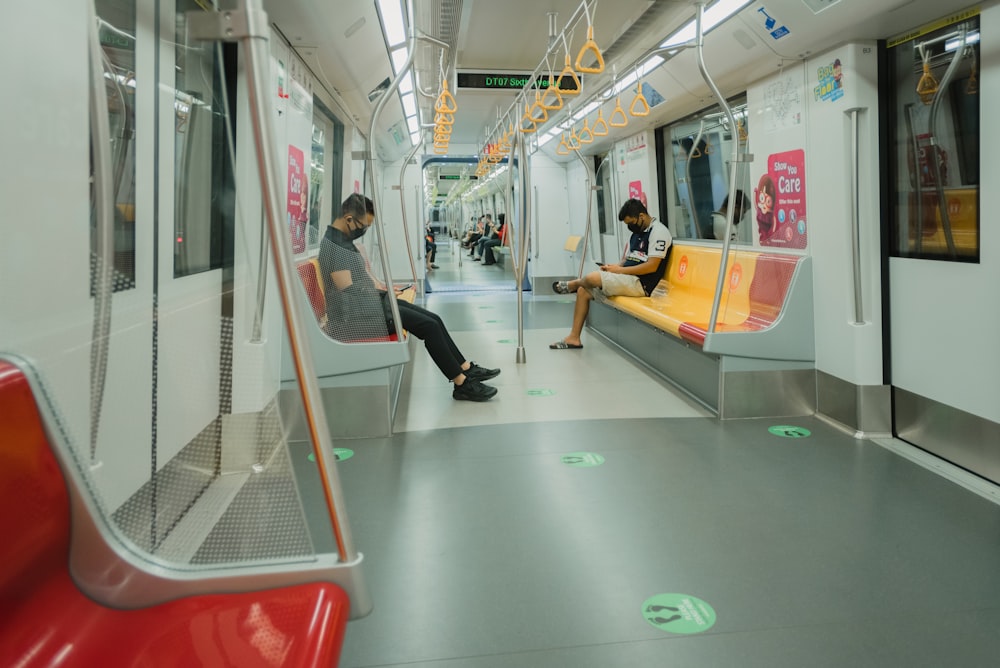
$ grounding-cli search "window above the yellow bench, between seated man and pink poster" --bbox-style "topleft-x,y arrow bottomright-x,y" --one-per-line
659,96 -> 751,243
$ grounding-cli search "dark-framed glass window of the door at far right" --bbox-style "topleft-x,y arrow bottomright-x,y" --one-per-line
888,16 -> 980,262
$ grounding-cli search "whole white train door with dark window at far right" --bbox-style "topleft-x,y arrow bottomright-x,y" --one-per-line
884,13 -> 1000,481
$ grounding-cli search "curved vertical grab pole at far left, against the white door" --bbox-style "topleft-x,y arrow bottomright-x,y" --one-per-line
87,2 -> 114,464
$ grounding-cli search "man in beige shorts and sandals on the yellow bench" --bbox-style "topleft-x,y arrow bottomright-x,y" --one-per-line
549,199 -> 673,350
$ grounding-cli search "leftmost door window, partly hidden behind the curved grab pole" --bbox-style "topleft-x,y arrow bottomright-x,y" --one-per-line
90,0 -> 136,292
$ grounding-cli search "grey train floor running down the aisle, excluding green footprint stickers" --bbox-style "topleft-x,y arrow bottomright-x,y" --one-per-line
337,240 -> 1000,668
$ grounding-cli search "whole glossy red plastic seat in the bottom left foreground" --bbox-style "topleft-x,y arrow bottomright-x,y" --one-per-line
0,361 -> 350,667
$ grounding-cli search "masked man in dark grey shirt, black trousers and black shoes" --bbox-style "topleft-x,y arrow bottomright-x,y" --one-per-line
319,193 -> 500,401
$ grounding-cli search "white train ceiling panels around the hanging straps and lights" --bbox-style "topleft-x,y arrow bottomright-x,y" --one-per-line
264,0 -> 980,188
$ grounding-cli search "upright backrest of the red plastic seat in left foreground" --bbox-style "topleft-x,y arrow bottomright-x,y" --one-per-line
0,360 -> 69,610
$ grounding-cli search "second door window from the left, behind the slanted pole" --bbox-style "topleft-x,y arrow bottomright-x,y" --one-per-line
174,0 -> 235,278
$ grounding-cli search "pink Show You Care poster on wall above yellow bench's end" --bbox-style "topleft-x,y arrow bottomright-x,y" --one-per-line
753,149 -> 807,248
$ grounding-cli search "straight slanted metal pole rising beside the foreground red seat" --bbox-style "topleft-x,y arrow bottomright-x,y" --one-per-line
237,0 -> 358,562
